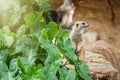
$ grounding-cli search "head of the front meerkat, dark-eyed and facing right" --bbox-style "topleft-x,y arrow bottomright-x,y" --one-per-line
72,21 -> 89,34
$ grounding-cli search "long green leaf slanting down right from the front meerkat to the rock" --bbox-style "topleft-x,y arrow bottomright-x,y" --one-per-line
57,36 -> 92,80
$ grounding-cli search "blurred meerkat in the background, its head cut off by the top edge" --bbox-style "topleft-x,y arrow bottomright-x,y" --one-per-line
56,0 -> 75,29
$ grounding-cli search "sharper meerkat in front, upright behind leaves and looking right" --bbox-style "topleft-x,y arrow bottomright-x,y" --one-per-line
70,21 -> 89,53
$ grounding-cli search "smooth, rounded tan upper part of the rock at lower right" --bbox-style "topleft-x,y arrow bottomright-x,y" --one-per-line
85,40 -> 120,80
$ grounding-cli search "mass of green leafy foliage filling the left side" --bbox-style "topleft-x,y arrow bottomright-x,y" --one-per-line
0,0 -> 91,80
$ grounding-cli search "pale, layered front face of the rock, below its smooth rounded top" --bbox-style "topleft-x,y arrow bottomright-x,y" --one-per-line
85,51 -> 118,80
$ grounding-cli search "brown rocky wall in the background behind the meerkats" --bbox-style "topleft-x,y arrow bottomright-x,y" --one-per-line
50,0 -> 120,48
